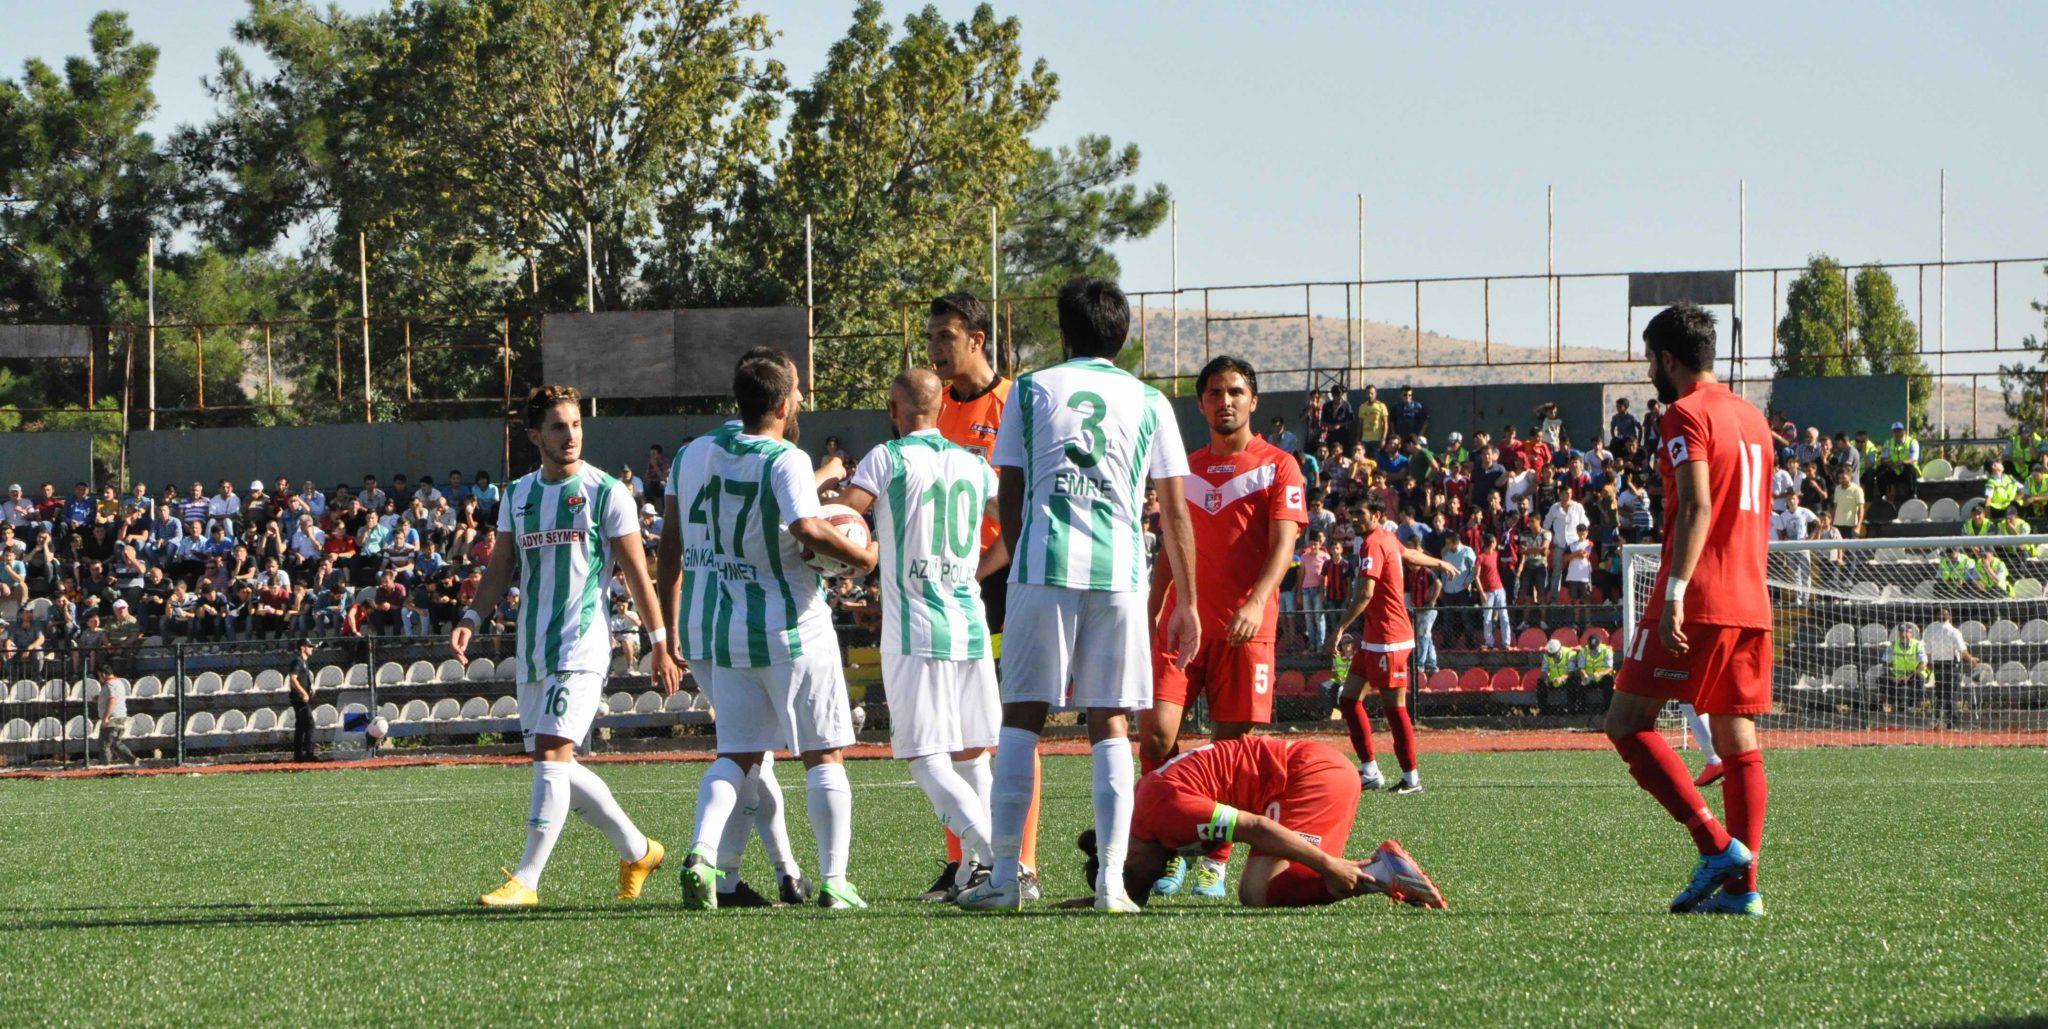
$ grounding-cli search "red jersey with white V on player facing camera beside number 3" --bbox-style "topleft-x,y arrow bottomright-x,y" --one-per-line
1165,437 -> 1309,642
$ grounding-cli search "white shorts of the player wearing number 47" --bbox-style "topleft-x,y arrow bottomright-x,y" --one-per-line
711,637 -> 854,754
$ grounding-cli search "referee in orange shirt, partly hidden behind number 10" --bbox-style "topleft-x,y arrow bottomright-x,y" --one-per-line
922,293 -> 1044,902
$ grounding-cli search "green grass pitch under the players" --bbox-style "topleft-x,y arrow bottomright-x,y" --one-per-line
0,748 -> 2048,1025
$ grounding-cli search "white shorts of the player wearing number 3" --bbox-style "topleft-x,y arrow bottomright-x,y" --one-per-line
1004,582 -> 1151,711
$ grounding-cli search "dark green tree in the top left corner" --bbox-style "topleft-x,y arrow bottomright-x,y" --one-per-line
0,12 -> 178,404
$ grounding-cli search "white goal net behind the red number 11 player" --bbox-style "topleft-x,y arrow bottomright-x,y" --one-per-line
1622,535 -> 2048,746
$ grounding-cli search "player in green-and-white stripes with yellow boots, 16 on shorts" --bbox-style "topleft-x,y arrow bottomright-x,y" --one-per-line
460,385 -> 682,908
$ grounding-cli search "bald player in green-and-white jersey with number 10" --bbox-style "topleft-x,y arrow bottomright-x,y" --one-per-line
840,369 -> 1008,892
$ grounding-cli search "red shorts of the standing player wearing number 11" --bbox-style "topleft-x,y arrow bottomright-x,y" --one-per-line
1614,621 -> 1772,715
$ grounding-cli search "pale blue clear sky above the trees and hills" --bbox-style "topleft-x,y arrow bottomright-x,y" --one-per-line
0,0 -> 2048,371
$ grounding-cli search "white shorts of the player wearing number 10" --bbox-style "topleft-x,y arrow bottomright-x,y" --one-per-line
883,654 -> 1004,760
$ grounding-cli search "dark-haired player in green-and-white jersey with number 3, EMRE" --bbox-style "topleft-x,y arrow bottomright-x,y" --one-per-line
958,277 -> 1202,912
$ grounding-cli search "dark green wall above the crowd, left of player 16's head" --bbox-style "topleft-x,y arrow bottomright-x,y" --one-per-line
129,418 -> 504,490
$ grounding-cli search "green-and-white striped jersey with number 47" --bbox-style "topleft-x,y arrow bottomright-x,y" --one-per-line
676,433 -> 834,668
